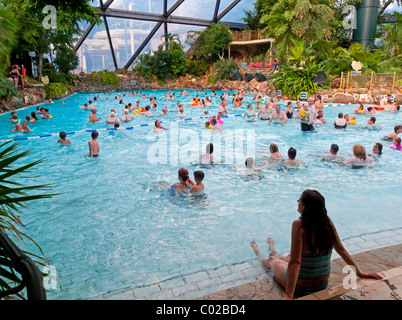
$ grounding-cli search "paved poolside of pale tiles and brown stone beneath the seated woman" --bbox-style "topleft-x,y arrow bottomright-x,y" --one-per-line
92,228 -> 402,300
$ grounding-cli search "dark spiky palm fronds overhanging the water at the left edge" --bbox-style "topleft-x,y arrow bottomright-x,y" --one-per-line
0,142 -> 55,299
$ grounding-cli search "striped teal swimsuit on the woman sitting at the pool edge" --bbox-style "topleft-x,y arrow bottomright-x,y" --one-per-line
286,250 -> 332,296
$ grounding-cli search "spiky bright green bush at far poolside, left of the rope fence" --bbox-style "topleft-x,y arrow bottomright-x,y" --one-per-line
269,59 -> 323,99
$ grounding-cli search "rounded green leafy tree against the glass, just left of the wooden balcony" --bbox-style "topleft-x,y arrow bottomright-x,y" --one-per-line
186,23 -> 233,63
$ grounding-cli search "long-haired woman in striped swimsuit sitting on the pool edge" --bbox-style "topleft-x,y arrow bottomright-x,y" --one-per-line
250,190 -> 382,300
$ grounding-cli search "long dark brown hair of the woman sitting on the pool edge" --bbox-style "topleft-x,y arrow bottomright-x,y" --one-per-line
299,190 -> 336,254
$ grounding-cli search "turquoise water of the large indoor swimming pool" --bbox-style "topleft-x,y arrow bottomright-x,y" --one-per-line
0,90 -> 402,299
